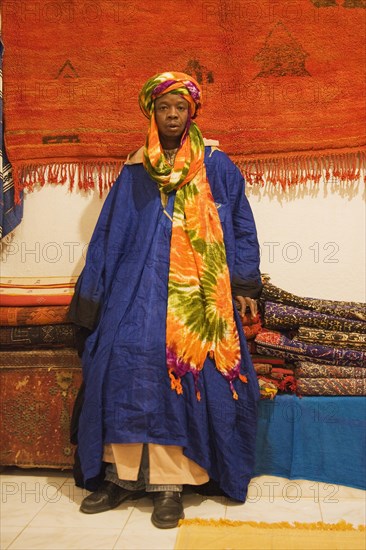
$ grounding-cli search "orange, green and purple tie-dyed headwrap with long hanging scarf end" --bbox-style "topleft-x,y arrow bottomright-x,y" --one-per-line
139,72 -> 247,399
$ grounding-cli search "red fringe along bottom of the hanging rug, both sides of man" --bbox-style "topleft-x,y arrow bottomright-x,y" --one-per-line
13,149 -> 366,203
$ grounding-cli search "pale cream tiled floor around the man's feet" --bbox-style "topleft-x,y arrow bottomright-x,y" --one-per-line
1,468 -> 366,550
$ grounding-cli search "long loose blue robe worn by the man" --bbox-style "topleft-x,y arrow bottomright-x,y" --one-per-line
71,147 -> 260,501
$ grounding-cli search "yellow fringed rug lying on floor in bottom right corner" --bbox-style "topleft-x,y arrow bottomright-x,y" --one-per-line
174,519 -> 366,550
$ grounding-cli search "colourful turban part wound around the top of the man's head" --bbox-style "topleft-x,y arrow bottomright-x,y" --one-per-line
139,72 -> 202,118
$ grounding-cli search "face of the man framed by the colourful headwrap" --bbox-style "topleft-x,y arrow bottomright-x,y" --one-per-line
155,93 -> 189,146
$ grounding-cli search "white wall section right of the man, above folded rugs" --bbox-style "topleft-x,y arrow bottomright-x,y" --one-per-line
247,182 -> 366,302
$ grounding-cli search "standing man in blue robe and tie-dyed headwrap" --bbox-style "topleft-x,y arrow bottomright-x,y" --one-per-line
70,73 -> 261,528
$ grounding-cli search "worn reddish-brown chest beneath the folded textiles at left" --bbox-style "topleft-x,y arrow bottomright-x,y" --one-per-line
0,349 -> 82,468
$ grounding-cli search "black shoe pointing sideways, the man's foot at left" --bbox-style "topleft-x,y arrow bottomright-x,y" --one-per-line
80,481 -> 145,514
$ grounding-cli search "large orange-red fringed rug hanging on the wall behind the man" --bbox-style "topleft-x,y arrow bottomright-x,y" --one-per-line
3,0 -> 366,190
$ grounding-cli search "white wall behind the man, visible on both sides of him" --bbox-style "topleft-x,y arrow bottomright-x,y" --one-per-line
1,177 -> 366,301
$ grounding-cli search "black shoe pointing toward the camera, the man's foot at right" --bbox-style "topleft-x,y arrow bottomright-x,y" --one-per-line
151,491 -> 184,529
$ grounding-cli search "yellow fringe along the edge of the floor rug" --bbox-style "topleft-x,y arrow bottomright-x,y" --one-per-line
178,518 -> 365,532
